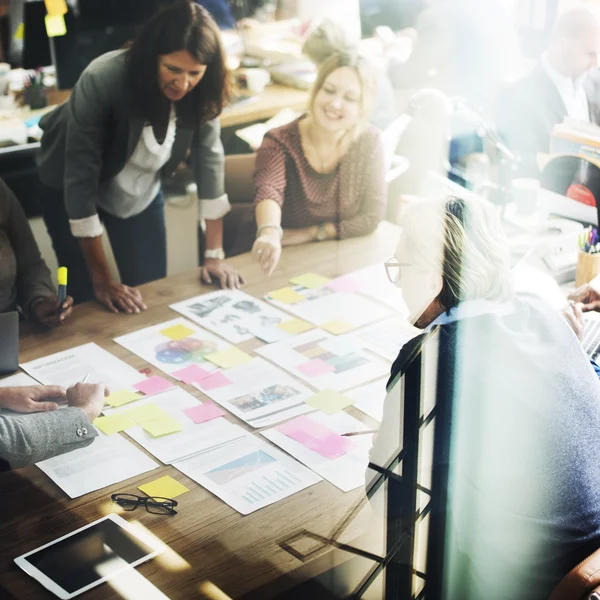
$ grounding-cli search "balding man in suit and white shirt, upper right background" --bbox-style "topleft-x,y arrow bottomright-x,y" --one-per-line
497,7 -> 600,176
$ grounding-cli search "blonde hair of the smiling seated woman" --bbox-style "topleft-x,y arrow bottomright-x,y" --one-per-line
308,52 -> 377,139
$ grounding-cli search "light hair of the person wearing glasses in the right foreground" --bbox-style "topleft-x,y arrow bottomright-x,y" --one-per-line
398,196 -> 514,311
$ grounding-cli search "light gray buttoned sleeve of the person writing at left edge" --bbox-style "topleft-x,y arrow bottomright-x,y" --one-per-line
0,407 -> 98,469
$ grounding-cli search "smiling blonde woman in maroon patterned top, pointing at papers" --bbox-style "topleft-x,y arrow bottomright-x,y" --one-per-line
230,54 -> 385,276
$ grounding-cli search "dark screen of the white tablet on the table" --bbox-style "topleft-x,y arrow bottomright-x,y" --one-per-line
27,519 -> 156,594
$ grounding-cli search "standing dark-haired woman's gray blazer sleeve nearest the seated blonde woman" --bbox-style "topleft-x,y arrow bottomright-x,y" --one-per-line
191,119 -> 231,220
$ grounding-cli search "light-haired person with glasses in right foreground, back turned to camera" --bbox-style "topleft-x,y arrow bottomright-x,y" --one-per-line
369,197 -> 600,600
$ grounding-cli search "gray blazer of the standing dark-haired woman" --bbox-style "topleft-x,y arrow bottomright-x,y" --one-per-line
38,50 -> 226,220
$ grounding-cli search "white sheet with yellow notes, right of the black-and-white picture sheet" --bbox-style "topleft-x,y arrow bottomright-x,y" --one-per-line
265,285 -> 393,328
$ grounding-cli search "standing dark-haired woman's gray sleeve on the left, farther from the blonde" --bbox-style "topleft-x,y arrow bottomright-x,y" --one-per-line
64,65 -> 110,232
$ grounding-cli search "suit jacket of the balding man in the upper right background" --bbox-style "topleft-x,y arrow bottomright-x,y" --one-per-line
497,63 -> 600,176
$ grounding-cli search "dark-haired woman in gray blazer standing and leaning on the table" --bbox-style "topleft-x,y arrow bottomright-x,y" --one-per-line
38,0 -> 243,313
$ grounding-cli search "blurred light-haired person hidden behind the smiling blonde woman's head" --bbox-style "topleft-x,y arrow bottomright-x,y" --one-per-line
302,19 -> 398,129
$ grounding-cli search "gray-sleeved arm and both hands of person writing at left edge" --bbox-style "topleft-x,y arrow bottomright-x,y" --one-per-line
0,383 -> 108,470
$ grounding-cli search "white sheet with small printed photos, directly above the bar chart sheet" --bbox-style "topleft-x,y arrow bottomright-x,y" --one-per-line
195,358 -> 314,427
